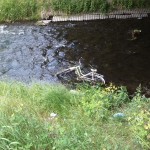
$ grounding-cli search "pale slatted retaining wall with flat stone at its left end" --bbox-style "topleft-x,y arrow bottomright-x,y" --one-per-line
37,9 -> 150,25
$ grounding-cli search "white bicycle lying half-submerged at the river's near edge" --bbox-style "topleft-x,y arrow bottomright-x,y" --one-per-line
56,60 -> 105,84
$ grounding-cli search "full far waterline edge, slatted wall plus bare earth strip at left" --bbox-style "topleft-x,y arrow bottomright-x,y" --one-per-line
0,8 -> 150,25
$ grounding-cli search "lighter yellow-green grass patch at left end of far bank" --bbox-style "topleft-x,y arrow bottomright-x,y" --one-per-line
0,0 -> 39,21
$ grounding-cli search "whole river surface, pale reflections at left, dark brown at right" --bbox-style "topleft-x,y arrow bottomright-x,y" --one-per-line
0,18 -> 150,91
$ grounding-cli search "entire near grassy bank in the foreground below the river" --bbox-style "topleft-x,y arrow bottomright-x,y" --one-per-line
0,82 -> 150,150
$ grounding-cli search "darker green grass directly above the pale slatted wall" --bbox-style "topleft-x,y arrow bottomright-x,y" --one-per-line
51,0 -> 150,14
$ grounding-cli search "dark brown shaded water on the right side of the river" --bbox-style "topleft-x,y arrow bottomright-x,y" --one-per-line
63,18 -> 150,94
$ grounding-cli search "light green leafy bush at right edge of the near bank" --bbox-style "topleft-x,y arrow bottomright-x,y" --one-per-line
127,89 -> 150,150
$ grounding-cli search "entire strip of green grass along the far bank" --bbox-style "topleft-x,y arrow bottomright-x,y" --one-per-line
0,0 -> 150,22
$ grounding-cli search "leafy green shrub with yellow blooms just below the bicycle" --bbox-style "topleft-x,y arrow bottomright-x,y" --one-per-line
77,84 -> 129,120
